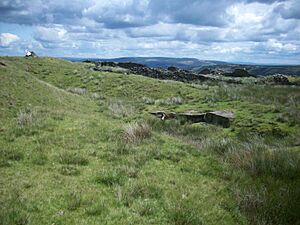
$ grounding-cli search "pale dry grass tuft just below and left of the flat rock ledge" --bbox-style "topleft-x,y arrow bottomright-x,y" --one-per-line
124,122 -> 151,143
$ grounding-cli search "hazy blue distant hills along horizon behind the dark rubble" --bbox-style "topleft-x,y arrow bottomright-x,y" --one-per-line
64,57 -> 300,76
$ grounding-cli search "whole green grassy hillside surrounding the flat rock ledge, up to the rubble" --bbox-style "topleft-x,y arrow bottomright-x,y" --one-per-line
0,57 -> 300,225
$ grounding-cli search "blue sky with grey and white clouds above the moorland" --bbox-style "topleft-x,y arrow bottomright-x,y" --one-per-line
0,0 -> 300,64
